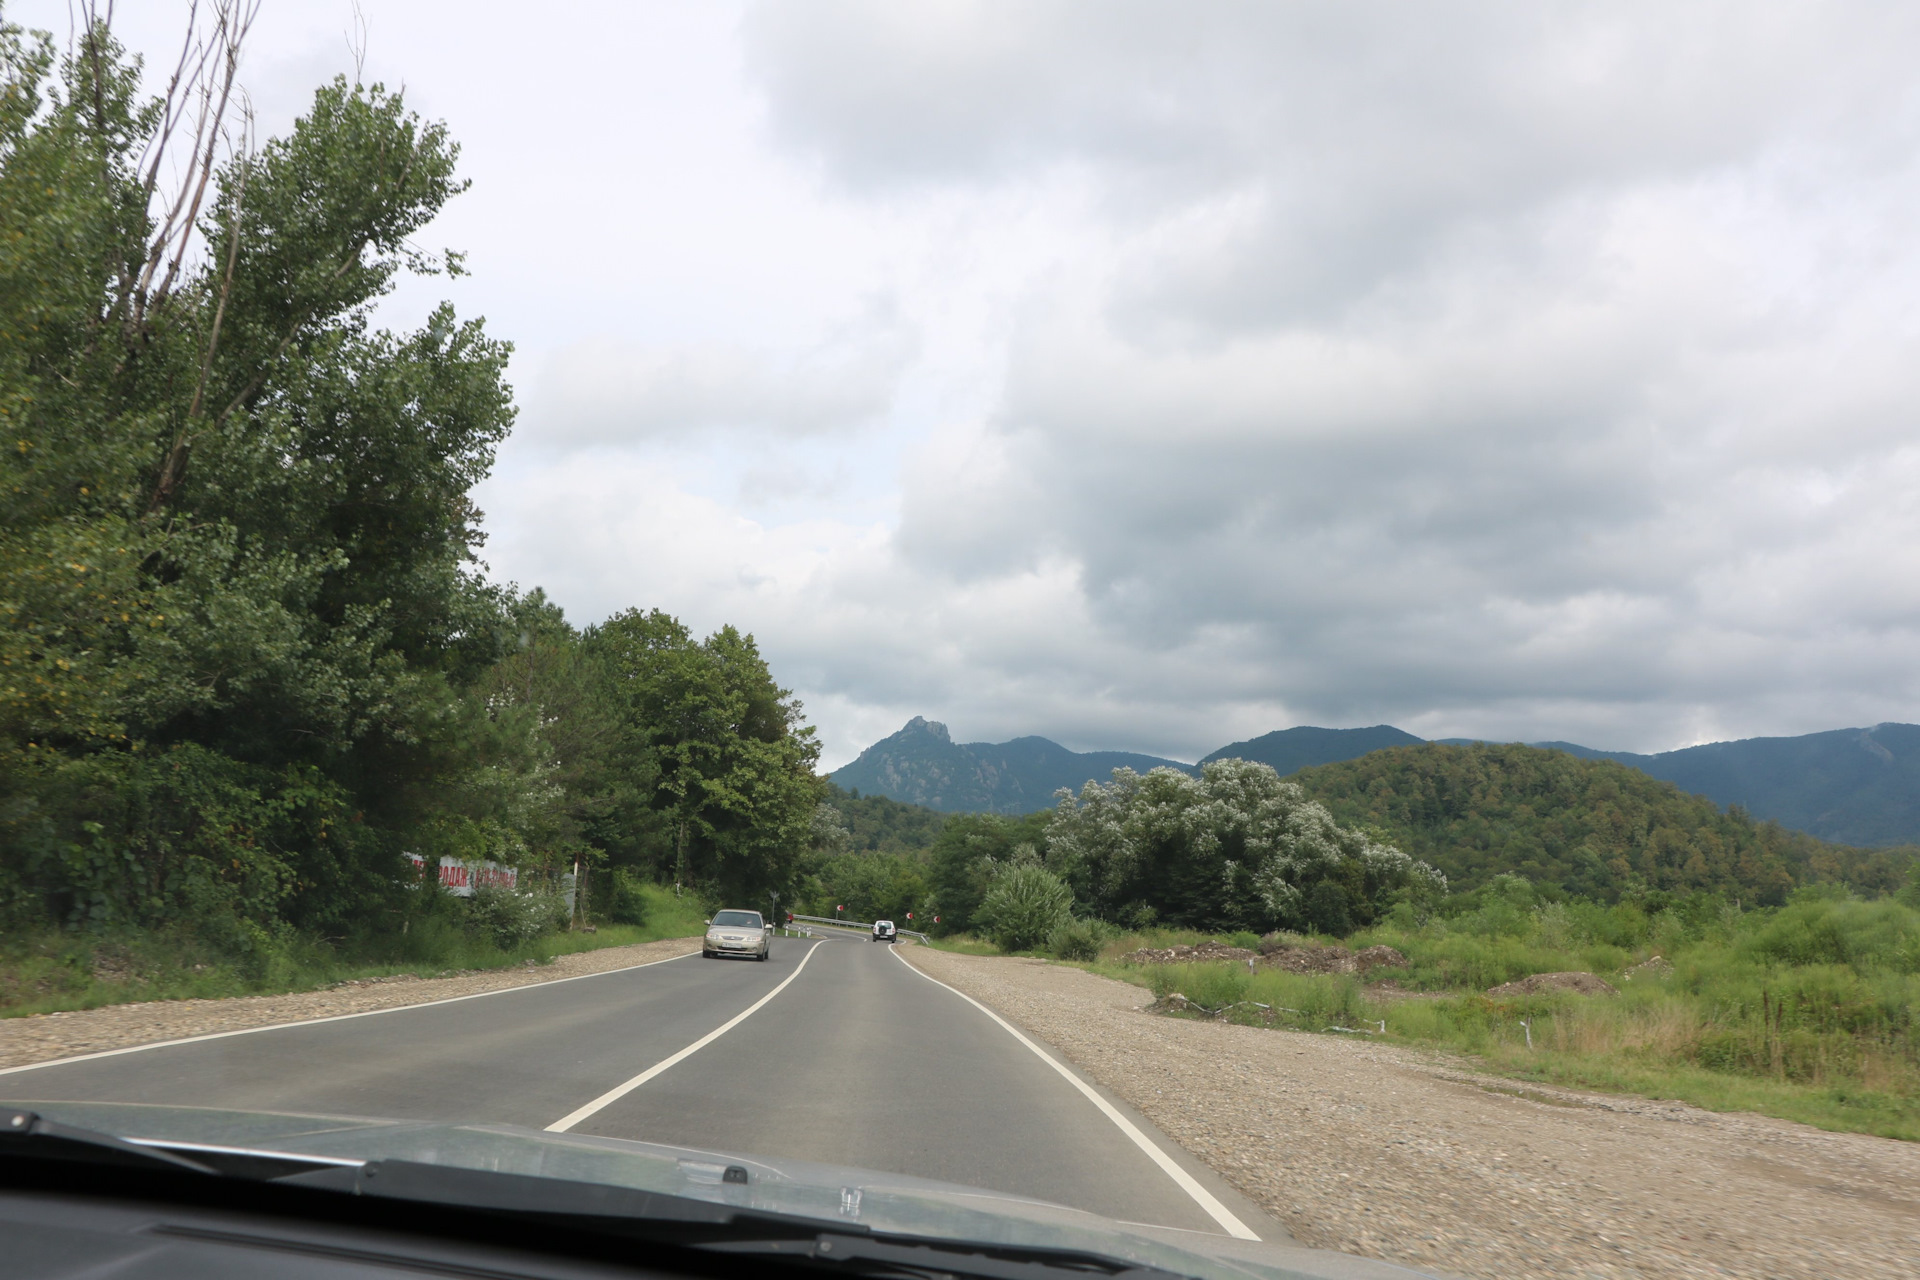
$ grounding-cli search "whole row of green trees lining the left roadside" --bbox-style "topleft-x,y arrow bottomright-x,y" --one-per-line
0,10 -> 822,965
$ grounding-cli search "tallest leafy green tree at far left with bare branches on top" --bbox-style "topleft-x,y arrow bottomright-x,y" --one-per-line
0,12 -> 513,940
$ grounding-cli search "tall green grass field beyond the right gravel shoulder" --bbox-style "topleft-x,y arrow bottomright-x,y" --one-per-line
1098,894 -> 1920,1140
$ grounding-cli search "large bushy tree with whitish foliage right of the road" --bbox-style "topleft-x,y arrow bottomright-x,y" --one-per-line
1046,760 -> 1446,933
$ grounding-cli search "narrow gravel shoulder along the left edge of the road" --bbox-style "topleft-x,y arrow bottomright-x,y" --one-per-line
0,936 -> 701,1069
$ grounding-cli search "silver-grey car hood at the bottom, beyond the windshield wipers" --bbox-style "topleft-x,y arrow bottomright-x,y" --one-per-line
12,1102 -> 1425,1280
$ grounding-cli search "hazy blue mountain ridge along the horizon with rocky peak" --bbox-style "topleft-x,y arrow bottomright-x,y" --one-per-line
831,716 -> 1920,846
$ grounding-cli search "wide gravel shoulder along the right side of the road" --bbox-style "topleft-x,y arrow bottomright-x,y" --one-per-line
902,946 -> 1920,1280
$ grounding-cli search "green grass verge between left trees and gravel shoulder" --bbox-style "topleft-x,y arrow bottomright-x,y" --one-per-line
0,885 -> 707,1017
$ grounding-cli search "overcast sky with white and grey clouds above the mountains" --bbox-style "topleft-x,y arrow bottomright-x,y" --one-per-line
26,0 -> 1920,766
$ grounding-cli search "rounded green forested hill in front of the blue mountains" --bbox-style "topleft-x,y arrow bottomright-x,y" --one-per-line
1292,743 -> 1910,904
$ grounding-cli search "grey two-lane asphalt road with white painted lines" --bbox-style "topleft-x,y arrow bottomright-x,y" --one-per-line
0,936 -> 1277,1240
